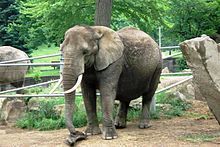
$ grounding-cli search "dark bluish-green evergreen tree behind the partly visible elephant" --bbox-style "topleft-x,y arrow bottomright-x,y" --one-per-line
0,0 -> 29,53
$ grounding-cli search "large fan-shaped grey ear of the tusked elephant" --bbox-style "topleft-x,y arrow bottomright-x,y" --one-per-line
94,26 -> 124,71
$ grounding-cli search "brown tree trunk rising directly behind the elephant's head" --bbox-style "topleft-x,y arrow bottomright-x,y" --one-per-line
95,0 -> 112,27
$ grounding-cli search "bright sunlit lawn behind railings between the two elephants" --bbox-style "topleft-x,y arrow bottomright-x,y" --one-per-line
26,45 -> 60,77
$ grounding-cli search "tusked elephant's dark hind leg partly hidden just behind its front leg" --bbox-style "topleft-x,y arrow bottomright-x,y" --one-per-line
115,101 -> 130,129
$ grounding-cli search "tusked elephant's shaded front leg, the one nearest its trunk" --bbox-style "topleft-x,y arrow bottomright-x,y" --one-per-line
81,79 -> 101,135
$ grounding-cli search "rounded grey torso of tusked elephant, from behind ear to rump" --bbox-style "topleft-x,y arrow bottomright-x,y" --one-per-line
118,27 -> 162,100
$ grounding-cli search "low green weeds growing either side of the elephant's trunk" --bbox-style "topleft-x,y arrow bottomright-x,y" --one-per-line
16,97 -> 87,131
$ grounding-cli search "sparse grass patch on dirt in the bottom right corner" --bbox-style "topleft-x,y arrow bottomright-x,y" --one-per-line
180,133 -> 220,143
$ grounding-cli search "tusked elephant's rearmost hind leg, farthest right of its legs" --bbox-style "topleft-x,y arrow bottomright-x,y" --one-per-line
139,65 -> 161,129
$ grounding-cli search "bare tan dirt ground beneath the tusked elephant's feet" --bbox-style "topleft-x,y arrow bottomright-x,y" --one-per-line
0,101 -> 220,147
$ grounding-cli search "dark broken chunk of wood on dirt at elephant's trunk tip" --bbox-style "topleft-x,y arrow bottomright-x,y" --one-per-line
65,131 -> 87,146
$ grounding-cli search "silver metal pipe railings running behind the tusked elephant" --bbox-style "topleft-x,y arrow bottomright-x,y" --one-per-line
0,44 -> 192,98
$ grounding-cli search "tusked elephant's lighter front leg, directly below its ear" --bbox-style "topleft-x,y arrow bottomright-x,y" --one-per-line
97,59 -> 122,139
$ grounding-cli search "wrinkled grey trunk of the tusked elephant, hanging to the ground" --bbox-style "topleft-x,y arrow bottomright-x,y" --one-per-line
63,56 -> 84,134
